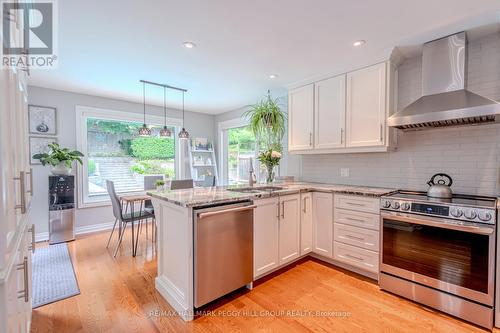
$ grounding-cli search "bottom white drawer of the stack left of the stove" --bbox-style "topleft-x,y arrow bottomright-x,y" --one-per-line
333,242 -> 378,273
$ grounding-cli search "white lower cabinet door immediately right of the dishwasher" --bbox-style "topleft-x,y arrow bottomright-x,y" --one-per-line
253,198 -> 279,277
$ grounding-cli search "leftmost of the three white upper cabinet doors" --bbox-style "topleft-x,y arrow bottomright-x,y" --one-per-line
288,84 -> 314,151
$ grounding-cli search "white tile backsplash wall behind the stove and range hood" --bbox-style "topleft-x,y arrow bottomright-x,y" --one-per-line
301,34 -> 500,195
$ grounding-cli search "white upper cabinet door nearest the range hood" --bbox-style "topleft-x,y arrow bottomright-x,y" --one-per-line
346,63 -> 386,147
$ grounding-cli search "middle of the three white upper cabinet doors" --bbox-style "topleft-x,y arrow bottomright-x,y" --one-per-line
314,75 -> 346,149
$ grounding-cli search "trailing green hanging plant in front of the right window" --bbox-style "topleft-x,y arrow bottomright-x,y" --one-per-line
243,90 -> 286,151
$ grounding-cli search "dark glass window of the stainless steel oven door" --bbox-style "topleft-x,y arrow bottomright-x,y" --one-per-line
382,219 -> 489,293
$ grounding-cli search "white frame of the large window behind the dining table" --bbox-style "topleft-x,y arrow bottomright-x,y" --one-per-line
75,105 -> 184,208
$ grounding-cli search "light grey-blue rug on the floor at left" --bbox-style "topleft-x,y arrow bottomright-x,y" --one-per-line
33,243 -> 80,308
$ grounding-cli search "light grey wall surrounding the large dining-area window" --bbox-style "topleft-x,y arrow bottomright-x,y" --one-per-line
28,86 -> 214,238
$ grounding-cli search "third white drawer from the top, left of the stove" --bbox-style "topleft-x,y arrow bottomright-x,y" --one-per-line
333,223 -> 379,252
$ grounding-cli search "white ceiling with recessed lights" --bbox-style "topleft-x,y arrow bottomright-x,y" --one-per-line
30,0 -> 500,114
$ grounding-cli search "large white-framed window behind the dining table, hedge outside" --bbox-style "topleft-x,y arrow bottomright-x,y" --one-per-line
77,107 -> 180,207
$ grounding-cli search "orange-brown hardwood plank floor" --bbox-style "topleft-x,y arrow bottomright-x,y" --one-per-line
31,231 -> 500,333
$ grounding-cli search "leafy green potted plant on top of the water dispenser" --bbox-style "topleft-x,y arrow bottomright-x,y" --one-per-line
33,142 -> 83,176
